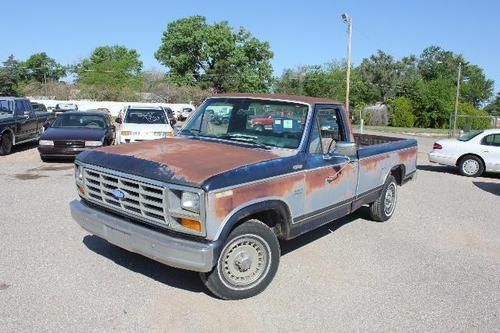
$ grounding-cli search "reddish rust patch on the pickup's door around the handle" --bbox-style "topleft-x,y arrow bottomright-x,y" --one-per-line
306,164 -> 355,195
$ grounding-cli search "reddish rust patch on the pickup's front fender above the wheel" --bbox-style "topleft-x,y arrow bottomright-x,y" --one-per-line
215,174 -> 304,222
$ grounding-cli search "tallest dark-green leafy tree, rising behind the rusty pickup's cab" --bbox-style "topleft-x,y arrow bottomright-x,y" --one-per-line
155,16 -> 273,92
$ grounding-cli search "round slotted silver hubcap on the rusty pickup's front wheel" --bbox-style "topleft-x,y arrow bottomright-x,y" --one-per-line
218,235 -> 271,290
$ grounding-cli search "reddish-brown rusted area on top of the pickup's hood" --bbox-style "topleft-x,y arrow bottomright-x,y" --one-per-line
98,137 -> 293,183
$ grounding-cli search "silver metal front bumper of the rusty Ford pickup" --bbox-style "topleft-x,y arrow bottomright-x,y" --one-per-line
70,200 -> 216,272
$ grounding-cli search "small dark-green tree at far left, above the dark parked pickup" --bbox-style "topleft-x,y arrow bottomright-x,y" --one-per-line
22,52 -> 66,82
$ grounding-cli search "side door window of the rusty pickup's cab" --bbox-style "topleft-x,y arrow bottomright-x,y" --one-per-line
309,107 -> 345,154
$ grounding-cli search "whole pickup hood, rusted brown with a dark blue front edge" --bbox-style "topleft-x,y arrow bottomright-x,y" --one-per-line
77,137 -> 294,186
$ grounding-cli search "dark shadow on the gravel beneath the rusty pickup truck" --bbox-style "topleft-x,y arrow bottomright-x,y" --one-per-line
83,207 -> 368,296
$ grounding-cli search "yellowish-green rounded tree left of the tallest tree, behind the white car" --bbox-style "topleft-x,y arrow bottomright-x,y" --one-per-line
74,45 -> 142,100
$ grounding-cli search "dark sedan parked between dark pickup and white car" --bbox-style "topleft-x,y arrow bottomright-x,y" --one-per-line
38,111 -> 115,161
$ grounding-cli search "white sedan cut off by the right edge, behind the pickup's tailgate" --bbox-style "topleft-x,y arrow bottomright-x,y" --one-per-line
429,129 -> 500,177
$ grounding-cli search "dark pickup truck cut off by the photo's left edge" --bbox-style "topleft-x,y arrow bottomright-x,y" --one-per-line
0,96 -> 55,155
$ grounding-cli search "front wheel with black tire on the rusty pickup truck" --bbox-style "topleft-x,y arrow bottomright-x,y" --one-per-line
200,220 -> 281,300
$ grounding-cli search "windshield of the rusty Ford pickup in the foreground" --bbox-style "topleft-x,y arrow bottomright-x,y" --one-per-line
180,98 -> 309,149
